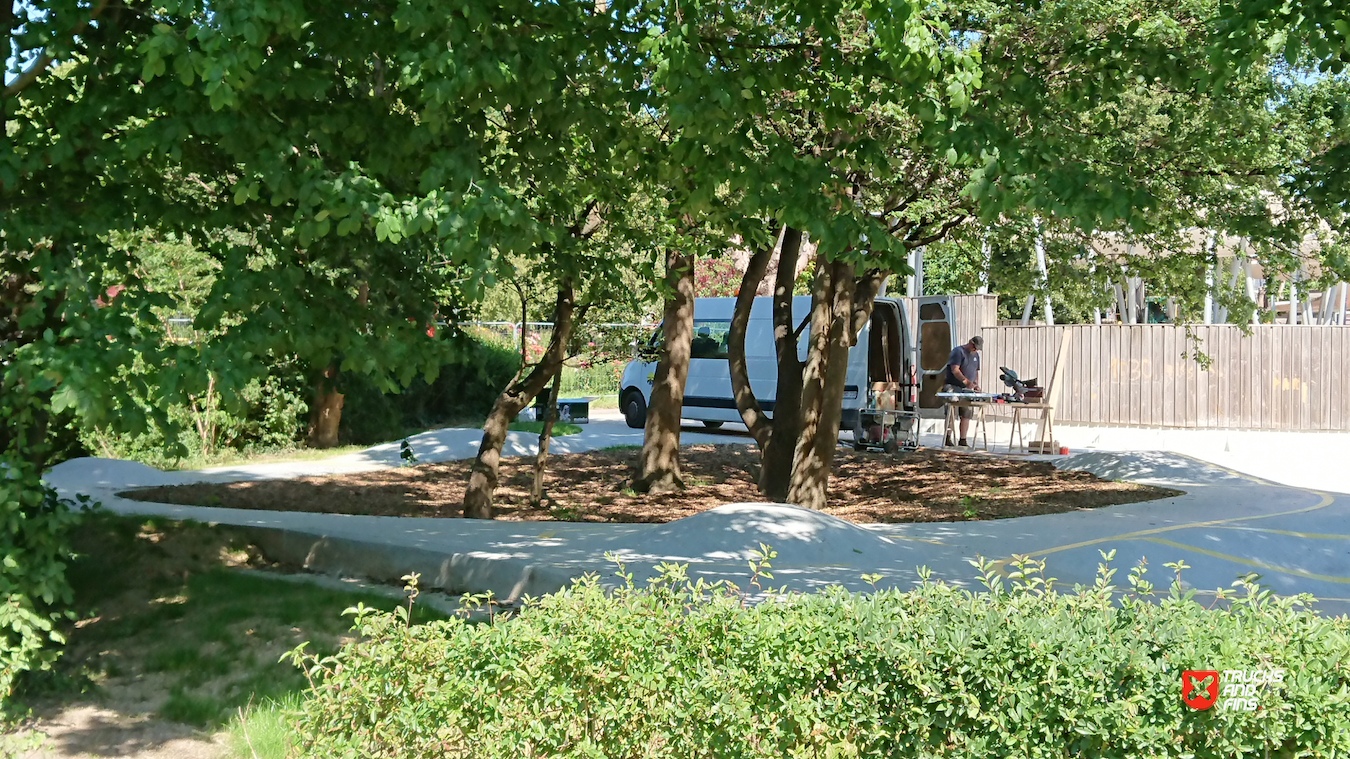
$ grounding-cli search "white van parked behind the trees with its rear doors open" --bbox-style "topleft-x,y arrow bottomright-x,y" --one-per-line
618,296 -> 918,429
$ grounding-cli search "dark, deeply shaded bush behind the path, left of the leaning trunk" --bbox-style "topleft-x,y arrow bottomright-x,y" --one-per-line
340,336 -> 520,446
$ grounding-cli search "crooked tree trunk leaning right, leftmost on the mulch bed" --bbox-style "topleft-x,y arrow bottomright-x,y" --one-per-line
464,278 -> 576,519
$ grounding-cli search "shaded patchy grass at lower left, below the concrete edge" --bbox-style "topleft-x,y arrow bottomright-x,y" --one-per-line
10,513 -> 440,756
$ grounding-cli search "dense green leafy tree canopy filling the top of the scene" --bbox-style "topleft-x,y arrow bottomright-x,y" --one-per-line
0,0 -> 1350,691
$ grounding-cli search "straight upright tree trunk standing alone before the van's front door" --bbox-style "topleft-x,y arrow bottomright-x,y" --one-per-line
633,250 -> 694,493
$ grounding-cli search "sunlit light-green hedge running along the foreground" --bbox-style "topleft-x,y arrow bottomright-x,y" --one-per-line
296,553 -> 1350,759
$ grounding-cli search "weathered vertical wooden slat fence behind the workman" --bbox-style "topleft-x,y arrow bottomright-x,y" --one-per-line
980,324 -> 1350,432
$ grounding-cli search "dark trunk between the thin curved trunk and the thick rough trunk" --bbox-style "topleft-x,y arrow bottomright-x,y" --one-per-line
759,227 -> 802,502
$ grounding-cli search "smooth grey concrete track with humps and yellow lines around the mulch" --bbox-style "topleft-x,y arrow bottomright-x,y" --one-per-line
47,417 -> 1350,614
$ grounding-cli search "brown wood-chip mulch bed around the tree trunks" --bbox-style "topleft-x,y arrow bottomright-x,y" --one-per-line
123,444 -> 1180,523
